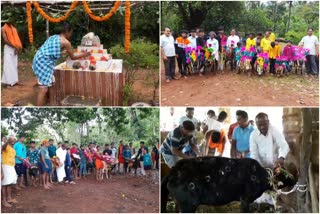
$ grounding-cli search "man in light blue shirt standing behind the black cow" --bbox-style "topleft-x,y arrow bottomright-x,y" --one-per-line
232,110 -> 254,158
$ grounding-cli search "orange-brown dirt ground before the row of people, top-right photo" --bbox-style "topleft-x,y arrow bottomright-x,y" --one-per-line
161,70 -> 319,106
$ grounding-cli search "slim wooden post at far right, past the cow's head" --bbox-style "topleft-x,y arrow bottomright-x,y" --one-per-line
297,108 -> 312,213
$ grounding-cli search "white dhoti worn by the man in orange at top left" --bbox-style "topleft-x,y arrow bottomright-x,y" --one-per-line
2,45 -> 18,86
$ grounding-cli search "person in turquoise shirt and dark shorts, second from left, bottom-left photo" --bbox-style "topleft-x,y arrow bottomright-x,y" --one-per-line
13,134 -> 27,189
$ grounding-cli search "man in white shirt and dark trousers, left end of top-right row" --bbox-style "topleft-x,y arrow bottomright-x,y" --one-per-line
160,27 -> 177,82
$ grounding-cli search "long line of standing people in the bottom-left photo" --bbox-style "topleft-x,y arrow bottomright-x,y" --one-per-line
1,135 -> 159,207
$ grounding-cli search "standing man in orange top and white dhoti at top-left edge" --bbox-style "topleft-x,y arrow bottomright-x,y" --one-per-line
1,17 -> 22,87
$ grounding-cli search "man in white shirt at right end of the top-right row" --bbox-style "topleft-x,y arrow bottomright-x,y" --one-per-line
299,28 -> 319,76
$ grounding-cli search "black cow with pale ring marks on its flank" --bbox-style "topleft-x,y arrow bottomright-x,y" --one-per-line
161,157 -> 295,213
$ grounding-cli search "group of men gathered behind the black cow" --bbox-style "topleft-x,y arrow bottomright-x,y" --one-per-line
160,108 -> 289,171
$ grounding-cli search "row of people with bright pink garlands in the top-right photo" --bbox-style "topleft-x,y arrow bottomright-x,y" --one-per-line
160,27 -> 319,82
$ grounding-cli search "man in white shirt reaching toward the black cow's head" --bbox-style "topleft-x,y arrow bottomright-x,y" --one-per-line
250,113 -> 289,205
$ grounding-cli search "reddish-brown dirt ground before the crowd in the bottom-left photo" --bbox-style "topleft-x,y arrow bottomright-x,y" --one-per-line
1,170 -> 159,213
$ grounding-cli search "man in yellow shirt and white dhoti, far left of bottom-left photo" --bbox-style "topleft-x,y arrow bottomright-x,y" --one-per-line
1,136 -> 18,207
